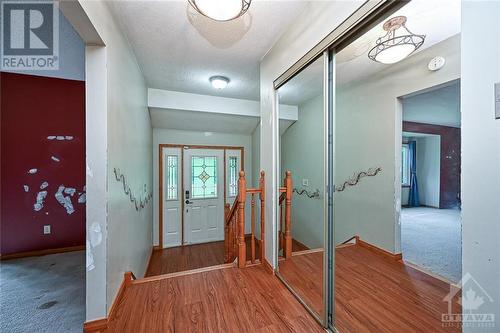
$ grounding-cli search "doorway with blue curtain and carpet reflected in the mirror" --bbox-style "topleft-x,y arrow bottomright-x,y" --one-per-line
401,80 -> 462,283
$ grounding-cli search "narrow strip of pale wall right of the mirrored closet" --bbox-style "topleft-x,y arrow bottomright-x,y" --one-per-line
461,1 -> 500,322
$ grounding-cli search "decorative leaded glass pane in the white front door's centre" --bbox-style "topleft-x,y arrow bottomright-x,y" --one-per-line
191,156 -> 217,199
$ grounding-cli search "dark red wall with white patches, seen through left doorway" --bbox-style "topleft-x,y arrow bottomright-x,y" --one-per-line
0,73 -> 85,255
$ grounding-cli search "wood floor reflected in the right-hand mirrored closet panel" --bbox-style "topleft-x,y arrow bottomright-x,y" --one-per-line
335,245 -> 461,333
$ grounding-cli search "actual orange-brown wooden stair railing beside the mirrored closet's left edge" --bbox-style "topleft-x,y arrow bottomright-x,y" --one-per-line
224,171 -> 265,268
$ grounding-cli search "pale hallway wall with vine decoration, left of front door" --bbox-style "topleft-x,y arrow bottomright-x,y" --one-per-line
79,1 -> 153,320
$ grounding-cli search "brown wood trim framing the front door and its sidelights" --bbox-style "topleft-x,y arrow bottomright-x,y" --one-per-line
158,143 -> 245,249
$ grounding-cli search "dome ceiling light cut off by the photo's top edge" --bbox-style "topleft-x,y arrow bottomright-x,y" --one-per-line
188,0 -> 252,21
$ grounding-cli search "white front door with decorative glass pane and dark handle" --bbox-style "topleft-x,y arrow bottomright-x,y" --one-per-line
184,149 -> 224,244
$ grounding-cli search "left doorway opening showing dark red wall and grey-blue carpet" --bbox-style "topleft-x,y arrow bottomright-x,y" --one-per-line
0,7 -> 87,332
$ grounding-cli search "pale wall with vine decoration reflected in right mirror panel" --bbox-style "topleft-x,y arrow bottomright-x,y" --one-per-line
335,35 -> 460,253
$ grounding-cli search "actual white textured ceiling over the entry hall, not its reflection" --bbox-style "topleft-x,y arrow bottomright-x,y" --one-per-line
109,0 -> 307,100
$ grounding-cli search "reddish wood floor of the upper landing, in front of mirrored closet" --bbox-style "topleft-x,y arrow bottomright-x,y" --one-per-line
106,265 -> 323,333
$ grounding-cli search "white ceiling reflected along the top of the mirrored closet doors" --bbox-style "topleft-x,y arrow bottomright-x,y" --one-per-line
278,0 -> 460,105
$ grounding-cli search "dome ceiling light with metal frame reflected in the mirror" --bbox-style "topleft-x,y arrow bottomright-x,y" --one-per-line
368,16 -> 425,64
